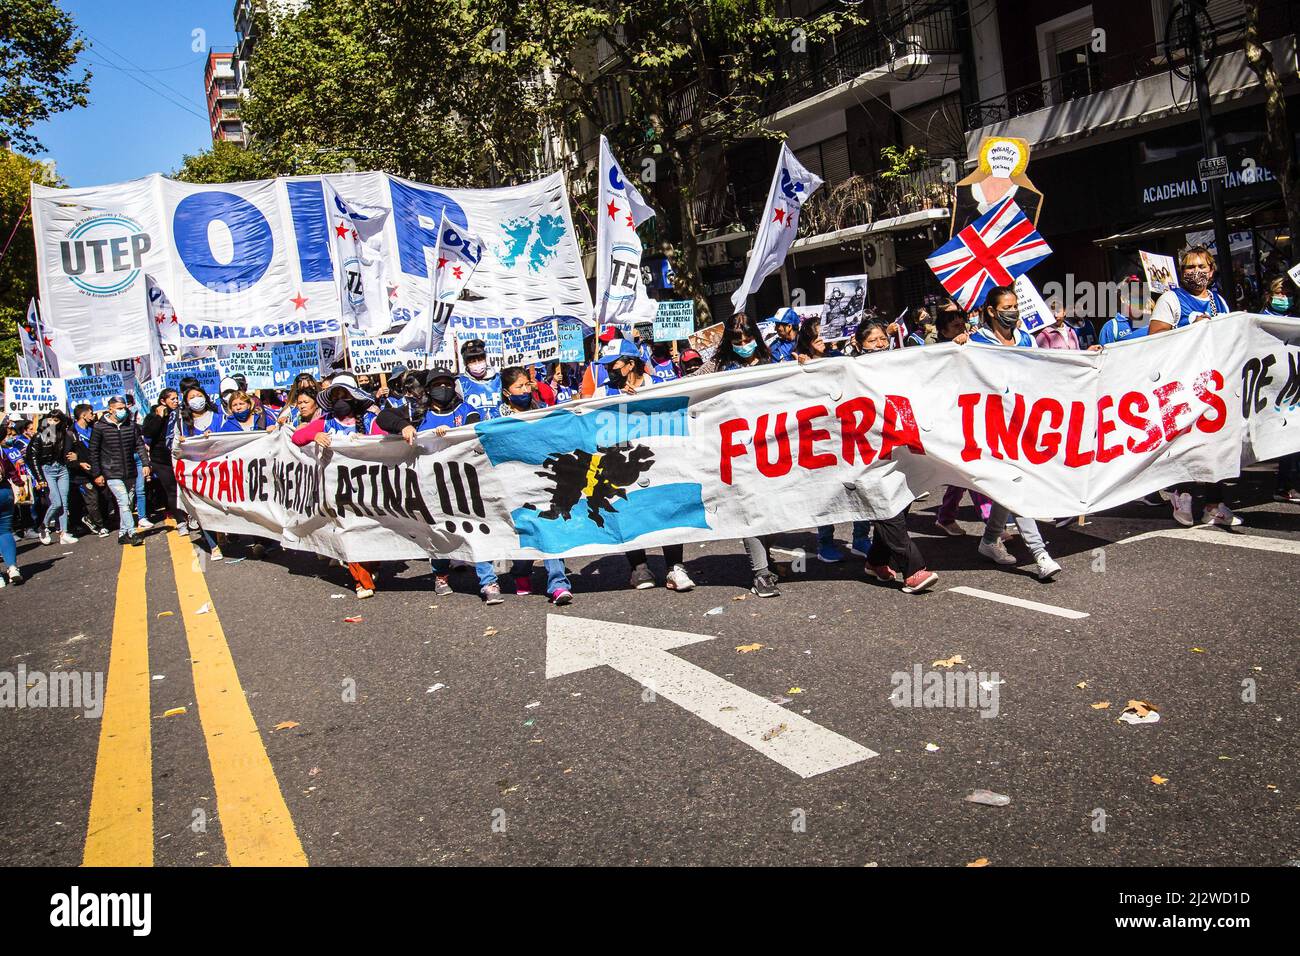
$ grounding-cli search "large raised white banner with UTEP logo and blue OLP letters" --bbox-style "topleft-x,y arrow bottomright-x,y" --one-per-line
31,166 -> 592,363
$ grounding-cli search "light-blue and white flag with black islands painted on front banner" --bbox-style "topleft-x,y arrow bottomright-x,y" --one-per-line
475,395 -> 710,554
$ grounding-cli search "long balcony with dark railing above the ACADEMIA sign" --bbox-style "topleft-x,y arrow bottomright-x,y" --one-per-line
963,0 -> 1300,144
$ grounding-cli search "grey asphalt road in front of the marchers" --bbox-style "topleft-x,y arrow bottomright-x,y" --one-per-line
0,473 -> 1300,866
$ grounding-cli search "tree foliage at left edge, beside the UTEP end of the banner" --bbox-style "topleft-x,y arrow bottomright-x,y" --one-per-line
0,150 -> 62,375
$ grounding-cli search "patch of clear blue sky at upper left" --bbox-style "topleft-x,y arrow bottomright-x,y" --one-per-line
34,0 -> 235,186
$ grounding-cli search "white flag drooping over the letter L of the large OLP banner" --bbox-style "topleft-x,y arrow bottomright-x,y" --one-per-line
321,177 -> 390,333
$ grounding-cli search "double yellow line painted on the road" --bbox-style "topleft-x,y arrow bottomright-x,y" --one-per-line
82,529 -> 307,866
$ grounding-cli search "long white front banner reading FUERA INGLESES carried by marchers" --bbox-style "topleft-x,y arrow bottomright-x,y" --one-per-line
176,313 -> 1300,561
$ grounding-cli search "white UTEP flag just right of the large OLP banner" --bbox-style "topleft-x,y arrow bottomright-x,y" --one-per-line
595,137 -> 655,325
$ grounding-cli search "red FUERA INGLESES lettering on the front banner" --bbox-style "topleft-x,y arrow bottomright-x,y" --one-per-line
718,368 -> 1227,485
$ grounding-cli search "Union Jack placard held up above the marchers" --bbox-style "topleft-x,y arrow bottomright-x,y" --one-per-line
926,196 -> 1052,311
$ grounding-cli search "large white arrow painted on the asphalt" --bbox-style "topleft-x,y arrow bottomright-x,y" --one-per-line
546,614 -> 878,779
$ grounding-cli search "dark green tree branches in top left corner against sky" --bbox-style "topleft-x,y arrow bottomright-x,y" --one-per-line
0,0 -> 90,152
